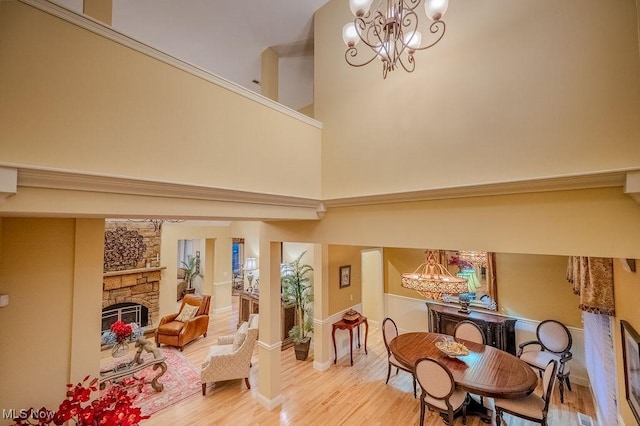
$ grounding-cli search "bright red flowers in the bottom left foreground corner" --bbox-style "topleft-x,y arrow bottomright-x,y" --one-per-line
12,376 -> 150,426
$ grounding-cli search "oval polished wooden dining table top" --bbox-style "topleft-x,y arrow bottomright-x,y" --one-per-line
389,332 -> 538,413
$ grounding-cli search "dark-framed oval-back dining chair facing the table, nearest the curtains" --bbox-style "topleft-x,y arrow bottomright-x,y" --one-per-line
518,319 -> 573,403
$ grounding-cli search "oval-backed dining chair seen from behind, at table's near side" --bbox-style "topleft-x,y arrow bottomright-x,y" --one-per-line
415,358 -> 469,426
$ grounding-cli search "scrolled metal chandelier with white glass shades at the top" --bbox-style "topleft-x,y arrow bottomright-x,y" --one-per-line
342,0 -> 449,78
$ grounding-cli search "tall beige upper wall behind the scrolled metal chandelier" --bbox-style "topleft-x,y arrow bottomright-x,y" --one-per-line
315,0 -> 640,198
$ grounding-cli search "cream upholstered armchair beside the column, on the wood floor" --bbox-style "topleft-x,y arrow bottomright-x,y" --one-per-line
200,314 -> 259,395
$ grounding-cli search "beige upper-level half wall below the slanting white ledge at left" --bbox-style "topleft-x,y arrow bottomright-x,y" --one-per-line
0,1 -> 320,198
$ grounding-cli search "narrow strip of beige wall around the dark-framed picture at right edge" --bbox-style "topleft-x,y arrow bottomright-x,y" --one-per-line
613,259 -> 640,426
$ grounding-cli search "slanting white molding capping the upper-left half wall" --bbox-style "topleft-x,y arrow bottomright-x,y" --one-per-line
19,0 -> 322,129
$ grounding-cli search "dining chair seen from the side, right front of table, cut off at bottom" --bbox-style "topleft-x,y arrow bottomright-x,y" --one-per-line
494,360 -> 558,426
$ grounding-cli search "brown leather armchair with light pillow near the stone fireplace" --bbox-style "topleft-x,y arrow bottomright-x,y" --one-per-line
156,294 -> 211,351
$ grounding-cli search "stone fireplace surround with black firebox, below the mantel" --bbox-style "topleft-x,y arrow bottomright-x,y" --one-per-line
102,267 -> 164,331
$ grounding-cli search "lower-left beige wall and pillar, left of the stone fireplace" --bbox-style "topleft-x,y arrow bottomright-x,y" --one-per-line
0,218 -> 104,424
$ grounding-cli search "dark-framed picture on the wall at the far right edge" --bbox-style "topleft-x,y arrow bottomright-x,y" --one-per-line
620,320 -> 640,424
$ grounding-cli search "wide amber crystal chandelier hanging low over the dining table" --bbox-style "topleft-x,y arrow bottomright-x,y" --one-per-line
401,251 -> 468,300
